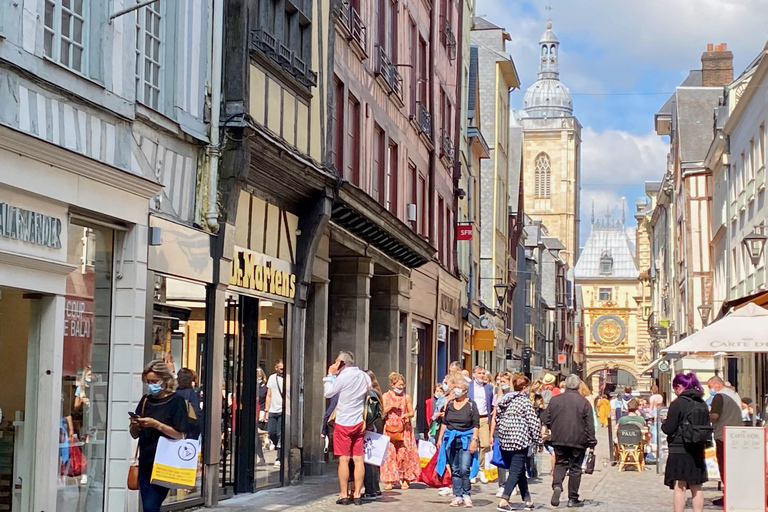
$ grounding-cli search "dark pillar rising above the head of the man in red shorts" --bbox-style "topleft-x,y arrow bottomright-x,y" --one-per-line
328,257 -> 373,368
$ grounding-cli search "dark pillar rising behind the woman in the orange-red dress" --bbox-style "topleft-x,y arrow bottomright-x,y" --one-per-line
369,274 -> 410,380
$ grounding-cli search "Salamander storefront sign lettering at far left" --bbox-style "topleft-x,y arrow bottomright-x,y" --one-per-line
0,203 -> 61,249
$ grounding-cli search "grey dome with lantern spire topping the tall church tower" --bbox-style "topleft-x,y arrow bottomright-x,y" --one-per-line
523,22 -> 573,118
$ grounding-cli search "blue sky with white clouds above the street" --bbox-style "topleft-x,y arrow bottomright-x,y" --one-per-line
477,0 -> 768,243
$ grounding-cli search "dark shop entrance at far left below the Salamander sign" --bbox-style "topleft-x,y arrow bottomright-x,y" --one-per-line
0,288 -> 40,512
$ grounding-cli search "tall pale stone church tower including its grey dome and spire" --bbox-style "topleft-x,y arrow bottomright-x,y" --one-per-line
515,21 -> 581,268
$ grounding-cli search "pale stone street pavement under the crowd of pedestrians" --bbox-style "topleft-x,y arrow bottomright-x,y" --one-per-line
210,429 -> 722,512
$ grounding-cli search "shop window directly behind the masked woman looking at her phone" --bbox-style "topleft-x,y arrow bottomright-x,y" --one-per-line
145,274 -> 206,504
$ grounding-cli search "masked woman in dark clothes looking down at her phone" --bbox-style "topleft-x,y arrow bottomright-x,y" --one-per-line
130,360 -> 200,512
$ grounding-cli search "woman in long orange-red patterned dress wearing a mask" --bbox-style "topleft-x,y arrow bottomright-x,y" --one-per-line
381,372 -> 421,491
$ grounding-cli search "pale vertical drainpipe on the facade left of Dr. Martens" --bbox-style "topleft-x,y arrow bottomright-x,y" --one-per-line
205,0 -> 224,231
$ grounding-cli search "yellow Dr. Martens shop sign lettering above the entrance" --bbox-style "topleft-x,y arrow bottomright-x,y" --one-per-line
229,247 -> 296,299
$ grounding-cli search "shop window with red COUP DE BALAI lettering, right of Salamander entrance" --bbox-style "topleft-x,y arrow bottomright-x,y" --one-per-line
57,223 -> 113,512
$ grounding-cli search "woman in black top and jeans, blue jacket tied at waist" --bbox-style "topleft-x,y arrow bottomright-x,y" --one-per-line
435,377 -> 480,508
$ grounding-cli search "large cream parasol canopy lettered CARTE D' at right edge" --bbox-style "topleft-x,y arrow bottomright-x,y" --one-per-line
661,302 -> 768,354
